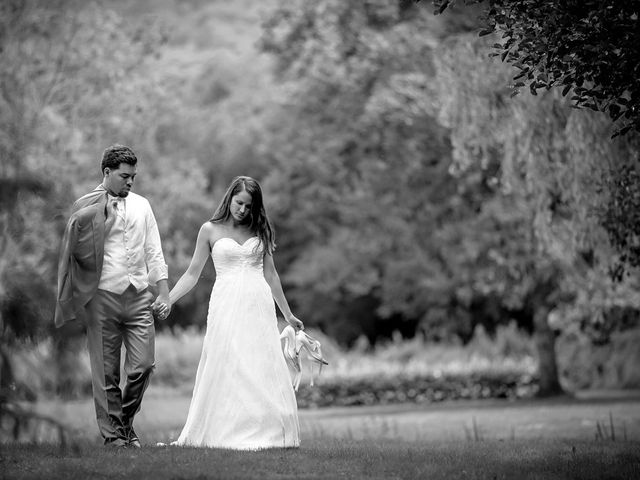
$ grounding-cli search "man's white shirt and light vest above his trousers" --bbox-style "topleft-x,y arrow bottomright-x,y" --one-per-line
98,192 -> 169,294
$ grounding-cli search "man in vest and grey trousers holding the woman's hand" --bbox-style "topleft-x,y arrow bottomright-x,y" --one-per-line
55,145 -> 170,447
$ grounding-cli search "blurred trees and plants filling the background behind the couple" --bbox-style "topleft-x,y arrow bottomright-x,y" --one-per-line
0,0 -> 640,430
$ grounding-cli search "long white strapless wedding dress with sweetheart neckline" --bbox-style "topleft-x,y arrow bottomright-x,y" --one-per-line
173,237 -> 300,450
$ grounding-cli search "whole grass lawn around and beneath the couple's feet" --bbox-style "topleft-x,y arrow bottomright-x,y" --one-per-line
0,389 -> 640,480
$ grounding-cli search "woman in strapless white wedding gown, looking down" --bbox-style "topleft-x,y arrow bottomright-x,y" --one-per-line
169,177 -> 304,450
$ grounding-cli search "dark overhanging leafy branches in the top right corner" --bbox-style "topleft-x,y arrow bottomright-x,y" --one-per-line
433,0 -> 640,288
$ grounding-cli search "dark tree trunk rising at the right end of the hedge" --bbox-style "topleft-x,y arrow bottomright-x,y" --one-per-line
533,305 -> 564,397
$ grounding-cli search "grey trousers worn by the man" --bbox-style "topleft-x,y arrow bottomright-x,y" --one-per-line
87,286 -> 155,444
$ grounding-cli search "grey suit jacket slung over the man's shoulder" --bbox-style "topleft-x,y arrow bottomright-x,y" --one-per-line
54,185 -> 107,327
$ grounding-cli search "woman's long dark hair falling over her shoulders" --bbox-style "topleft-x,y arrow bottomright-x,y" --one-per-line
209,176 -> 276,254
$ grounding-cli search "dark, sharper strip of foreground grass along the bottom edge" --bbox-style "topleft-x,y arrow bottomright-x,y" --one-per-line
0,438 -> 640,480
